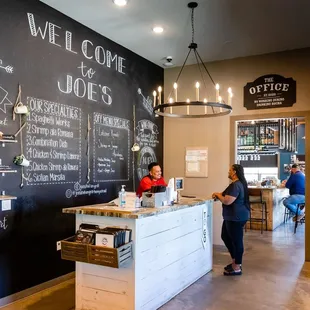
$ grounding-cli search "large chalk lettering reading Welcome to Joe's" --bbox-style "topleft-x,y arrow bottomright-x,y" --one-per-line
27,13 -> 126,105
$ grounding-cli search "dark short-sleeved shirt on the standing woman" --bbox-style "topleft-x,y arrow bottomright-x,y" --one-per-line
222,180 -> 250,222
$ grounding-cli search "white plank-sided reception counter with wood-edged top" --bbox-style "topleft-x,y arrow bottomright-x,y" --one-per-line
63,198 -> 213,310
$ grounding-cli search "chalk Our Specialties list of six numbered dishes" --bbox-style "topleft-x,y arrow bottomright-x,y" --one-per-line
25,97 -> 82,185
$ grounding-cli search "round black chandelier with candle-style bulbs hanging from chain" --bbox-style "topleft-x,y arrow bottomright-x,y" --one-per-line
153,2 -> 233,118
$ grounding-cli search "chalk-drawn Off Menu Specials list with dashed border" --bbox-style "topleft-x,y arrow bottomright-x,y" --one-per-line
93,112 -> 130,182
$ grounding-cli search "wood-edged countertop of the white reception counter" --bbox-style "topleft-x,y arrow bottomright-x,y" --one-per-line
62,197 -> 213,219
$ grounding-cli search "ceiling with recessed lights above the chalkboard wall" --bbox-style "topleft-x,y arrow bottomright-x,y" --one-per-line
41,0 -> 310,66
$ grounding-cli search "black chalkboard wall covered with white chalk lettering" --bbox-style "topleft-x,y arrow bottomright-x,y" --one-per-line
0,0 -> 163,298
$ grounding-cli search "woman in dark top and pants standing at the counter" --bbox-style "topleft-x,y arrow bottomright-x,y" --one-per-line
212,164 -> 250,276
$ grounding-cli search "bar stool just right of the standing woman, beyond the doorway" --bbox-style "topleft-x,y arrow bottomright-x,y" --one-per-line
248,188 -> 268,234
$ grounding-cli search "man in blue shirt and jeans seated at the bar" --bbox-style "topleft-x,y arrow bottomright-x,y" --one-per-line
282,164 -> 305,221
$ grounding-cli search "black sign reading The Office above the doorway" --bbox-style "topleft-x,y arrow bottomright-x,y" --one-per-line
244,74 -> 296,110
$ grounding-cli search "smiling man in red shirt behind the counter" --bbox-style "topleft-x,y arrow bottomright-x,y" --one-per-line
136,162 -> 167,197
